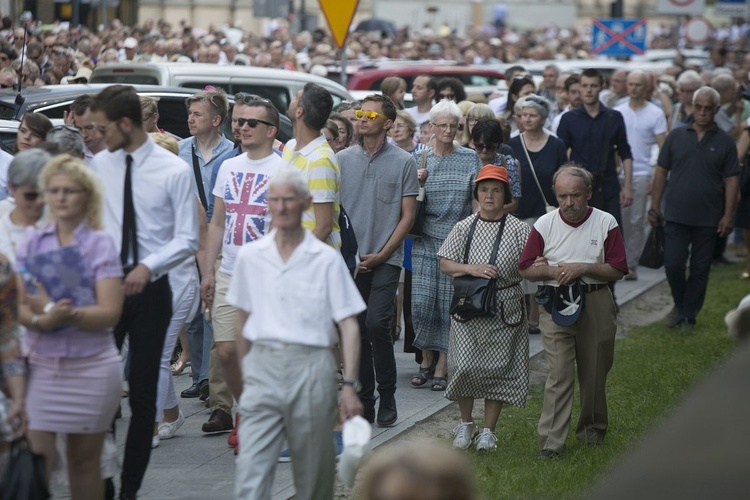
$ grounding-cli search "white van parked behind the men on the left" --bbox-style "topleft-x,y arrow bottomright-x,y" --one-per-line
89,63 -> 353,112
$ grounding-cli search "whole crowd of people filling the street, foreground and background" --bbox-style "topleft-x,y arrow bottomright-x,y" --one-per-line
0,9 -> 750,498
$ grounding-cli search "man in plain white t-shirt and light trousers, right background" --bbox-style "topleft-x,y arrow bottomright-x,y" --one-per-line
615,71 -> 667,280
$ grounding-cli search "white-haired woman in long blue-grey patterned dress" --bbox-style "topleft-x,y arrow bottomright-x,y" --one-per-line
411,100 -> 482,391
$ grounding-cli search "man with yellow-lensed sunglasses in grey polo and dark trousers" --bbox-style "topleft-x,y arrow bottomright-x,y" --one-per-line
336,95 -> 419,427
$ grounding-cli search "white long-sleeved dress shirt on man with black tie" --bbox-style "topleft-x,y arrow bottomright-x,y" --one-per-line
91,138 -> 198,281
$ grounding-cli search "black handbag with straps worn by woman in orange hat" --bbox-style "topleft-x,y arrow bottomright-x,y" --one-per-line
450,214 -> 507,323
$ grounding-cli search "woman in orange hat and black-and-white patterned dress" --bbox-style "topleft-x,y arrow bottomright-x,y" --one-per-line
438,165 -> 531,451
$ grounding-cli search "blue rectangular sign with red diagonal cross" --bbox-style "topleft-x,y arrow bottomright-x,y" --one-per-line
591,19 -> 647,56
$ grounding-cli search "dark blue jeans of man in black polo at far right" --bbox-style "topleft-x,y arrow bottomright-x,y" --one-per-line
664,222 -> 716,321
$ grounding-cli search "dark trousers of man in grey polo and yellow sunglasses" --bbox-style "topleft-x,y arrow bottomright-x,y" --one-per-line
355,264 -> 401,408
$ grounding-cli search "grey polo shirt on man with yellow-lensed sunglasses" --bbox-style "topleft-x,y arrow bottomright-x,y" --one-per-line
336,141 -> 419,267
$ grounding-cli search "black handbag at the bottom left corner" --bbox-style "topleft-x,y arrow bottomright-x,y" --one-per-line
0,438 -> 50,500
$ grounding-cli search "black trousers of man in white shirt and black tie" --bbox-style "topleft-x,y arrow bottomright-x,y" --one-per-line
115,275 -> 172,495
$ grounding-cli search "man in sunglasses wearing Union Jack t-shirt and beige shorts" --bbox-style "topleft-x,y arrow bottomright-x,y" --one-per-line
201,100 -> 285,449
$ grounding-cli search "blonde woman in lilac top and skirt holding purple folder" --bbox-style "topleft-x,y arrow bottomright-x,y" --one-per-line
17,155 -> 123,499
